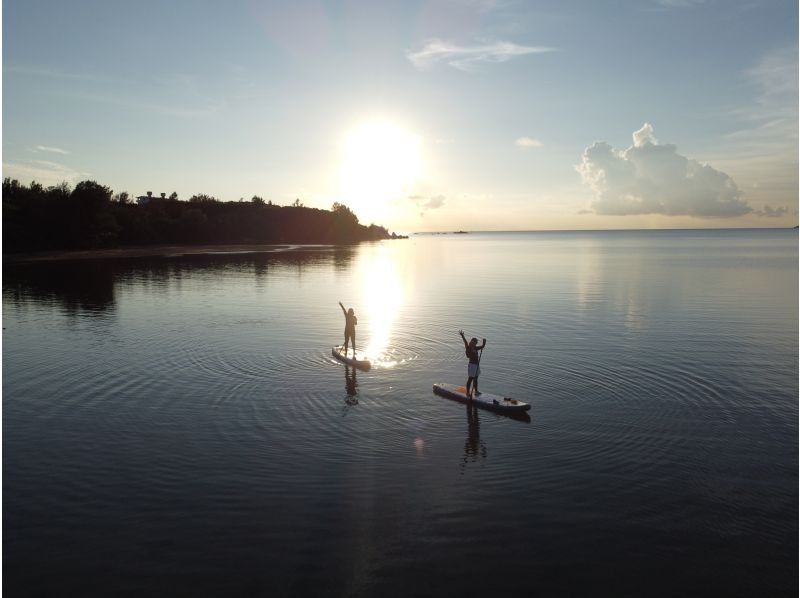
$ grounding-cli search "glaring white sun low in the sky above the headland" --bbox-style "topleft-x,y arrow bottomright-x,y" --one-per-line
341,120 -> 421,224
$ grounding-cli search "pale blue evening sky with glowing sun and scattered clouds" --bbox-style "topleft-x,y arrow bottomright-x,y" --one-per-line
2,0 -> 798,232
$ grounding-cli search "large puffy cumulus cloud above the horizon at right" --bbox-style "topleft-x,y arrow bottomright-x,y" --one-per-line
576,123 -> 753,218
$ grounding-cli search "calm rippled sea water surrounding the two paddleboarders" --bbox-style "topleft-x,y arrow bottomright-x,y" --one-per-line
2,230 -> 798,597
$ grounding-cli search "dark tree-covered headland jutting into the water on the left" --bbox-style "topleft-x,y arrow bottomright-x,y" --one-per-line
3,178 -> 402,254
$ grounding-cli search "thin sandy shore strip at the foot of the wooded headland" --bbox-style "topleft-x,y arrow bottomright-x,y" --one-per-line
3,244 -> 329,263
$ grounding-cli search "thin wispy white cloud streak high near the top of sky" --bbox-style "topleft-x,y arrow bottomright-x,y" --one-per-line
406,39 -> 555,71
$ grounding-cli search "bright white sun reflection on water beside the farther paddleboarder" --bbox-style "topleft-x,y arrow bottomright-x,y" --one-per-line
362,251 -> 403,367
